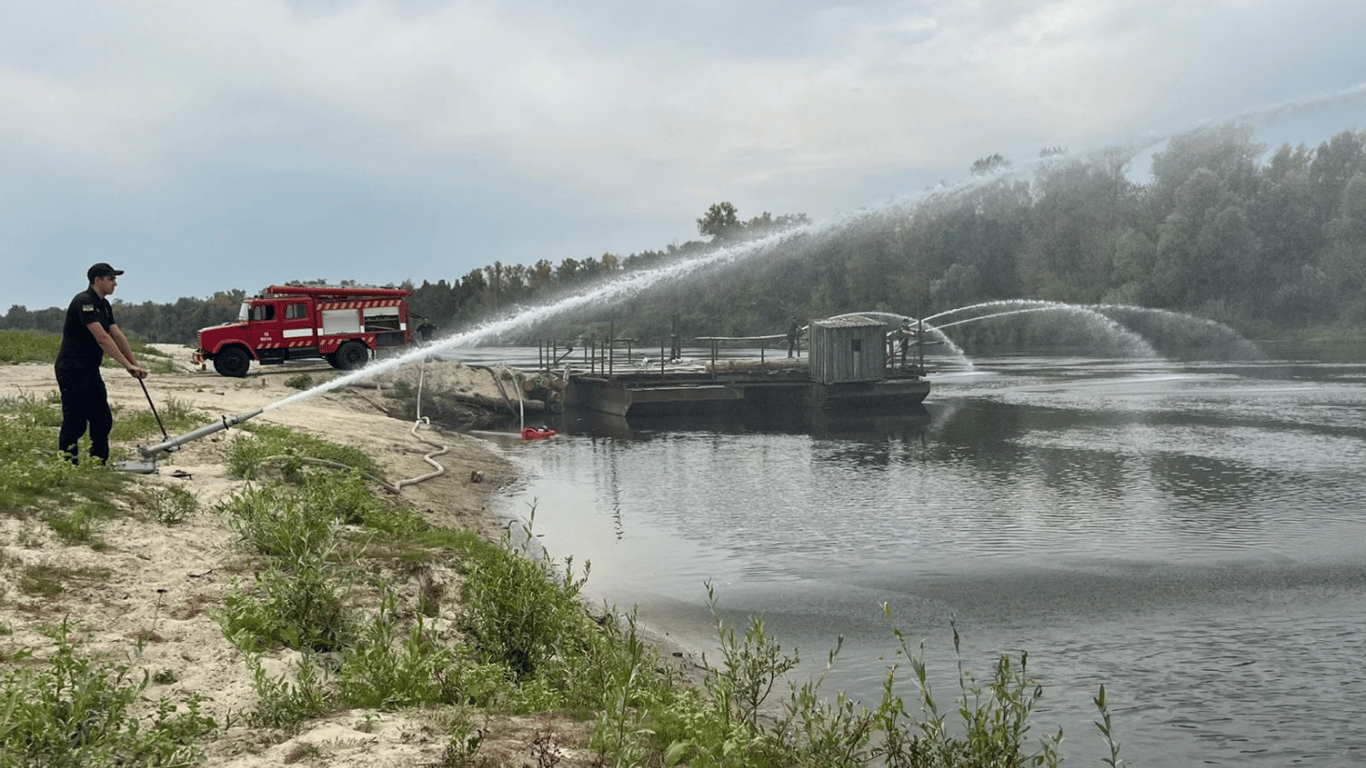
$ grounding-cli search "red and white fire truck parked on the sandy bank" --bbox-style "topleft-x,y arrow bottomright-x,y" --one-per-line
194,286 -> 413,377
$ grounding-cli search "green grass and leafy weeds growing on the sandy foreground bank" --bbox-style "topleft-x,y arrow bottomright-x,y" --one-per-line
0,368 -> 1121,768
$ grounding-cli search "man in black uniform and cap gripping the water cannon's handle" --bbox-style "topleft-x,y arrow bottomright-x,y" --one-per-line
56,262 -> 148,463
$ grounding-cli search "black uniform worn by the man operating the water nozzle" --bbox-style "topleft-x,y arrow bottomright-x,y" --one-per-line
55,288 -> 115,463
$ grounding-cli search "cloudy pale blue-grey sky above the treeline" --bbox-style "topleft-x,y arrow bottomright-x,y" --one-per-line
0,0 -> 1366,312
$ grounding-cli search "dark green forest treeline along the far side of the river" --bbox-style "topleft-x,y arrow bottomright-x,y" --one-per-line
0,124 -> 1366,344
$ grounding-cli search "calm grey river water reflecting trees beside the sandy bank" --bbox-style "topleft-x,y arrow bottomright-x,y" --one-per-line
490,351 -> 1366,767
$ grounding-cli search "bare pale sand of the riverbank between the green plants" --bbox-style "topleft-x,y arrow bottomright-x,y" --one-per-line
0,347 -> 672,768
